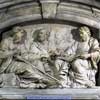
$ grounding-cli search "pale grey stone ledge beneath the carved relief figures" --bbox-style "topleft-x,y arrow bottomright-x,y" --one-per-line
0,87 -> 100,100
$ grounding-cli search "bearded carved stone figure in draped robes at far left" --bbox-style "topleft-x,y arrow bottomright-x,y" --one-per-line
0,27 -> 45,88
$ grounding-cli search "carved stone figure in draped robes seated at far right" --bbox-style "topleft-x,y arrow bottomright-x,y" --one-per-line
59,26 -> 100,88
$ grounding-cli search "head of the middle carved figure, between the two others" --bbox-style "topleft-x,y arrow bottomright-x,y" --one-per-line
33,28 -> 49,42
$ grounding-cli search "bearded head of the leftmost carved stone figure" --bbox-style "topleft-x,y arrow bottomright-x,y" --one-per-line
12,26 -> 27,43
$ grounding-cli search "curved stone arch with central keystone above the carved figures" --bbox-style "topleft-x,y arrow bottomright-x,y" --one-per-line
0,0 -> 100,30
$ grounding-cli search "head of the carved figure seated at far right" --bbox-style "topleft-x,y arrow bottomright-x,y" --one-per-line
79,26 -> 91,41
